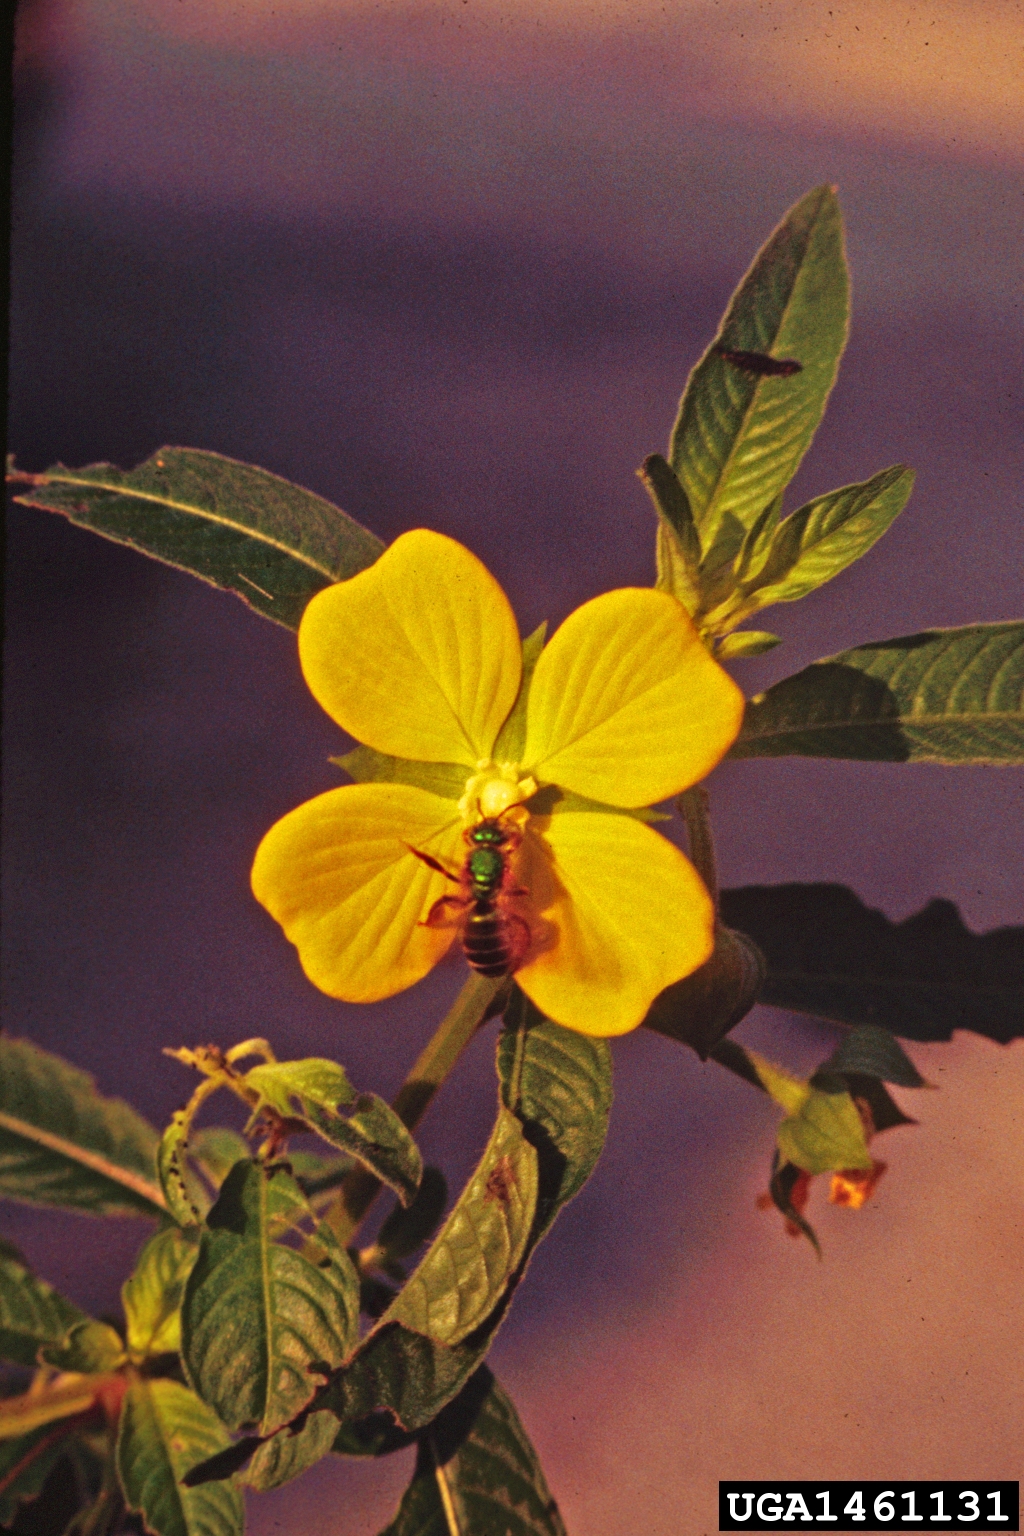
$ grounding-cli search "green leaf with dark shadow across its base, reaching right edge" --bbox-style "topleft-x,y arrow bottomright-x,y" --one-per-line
729,621 -> 1024,763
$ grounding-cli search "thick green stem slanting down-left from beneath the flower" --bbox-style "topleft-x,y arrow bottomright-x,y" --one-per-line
324,975 -> 508,1244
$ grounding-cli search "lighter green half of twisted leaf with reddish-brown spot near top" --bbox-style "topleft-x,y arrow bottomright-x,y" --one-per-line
381,1107 -> 537,1346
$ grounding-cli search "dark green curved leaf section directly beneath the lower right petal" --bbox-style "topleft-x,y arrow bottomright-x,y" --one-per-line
497,988 -> 611,1243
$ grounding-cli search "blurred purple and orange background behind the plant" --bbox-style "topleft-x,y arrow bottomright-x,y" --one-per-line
3,0 -> 1024,1536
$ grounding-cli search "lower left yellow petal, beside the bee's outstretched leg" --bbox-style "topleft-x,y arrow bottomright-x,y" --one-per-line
252,783 -> 465,1003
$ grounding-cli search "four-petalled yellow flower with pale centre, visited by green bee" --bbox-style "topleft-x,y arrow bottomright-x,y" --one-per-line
252,528 -> 743,1035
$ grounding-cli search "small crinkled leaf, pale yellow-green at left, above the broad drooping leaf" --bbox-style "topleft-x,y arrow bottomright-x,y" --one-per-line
244,1057 -> 424,1204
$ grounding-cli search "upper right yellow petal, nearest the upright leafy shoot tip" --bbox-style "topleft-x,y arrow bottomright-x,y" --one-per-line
525,578 -> 743,808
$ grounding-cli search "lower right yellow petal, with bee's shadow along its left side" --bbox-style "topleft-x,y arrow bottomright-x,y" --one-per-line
516,811 -> 714,1035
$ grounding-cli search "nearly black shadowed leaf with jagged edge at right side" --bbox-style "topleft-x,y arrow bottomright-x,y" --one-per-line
722,885 -> 1024,1044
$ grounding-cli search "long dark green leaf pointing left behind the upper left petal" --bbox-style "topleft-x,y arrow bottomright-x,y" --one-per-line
12,447 -> 384,630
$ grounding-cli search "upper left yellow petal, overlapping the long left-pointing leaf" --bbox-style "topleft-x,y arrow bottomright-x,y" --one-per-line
299,528 -> 522,766
